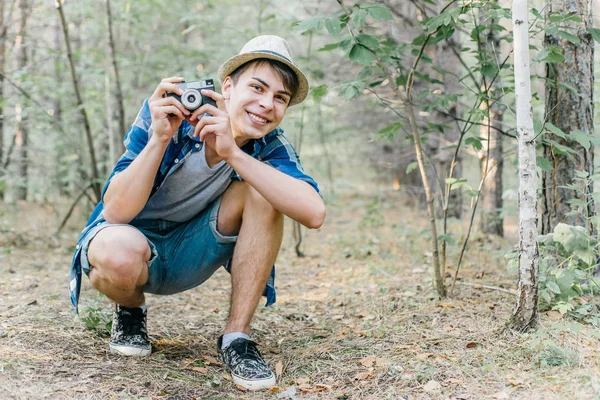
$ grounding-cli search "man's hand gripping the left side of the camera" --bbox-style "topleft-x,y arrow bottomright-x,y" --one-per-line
148,77 -> 191,143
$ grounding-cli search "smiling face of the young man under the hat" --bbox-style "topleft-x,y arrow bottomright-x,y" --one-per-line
223,63 -> 292,146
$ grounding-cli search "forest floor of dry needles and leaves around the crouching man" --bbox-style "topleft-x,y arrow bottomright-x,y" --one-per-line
0,188 -> 600,400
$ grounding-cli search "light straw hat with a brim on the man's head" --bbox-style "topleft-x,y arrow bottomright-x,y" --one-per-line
218,35 -> 308,106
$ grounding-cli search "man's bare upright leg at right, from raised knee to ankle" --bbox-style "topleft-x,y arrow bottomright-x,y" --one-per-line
217,182 -> 283,334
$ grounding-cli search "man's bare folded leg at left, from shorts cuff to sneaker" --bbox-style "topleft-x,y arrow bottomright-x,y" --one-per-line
88,226 -> 151,307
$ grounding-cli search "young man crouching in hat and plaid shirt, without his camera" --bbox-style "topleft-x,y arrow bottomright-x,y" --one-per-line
69,36 -> 325,390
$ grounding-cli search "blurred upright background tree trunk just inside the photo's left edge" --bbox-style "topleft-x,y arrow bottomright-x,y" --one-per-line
15,0 -> 28,200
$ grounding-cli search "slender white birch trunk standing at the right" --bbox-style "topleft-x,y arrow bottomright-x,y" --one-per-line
510,0 -> 539,331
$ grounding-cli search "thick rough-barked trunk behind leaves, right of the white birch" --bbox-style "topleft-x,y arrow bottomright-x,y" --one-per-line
542,0 -> 594,234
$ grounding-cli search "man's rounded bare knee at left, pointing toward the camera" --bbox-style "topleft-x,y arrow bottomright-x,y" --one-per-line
88,227 -> 151,291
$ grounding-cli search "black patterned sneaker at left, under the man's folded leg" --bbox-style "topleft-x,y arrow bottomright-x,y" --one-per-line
109,305 -> 152,357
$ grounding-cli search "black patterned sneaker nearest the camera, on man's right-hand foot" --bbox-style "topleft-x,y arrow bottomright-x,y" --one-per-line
217,336 -> 275,390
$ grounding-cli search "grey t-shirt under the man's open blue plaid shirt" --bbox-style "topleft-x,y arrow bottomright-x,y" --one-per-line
137,144 -> 232,222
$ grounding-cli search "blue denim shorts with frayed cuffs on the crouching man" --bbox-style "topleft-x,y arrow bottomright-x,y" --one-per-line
81,197 -> 237,294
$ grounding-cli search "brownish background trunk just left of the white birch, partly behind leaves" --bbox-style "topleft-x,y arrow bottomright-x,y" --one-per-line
479,7 -> 504,236
